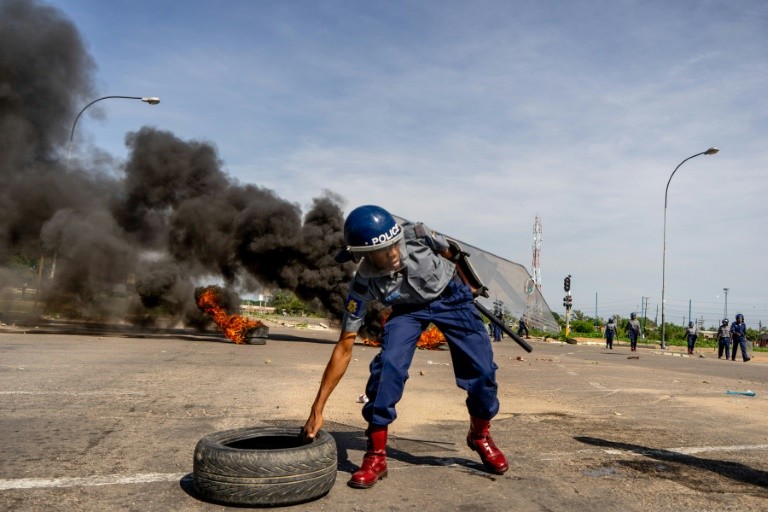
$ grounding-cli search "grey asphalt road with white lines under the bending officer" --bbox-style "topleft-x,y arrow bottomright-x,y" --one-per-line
0,326 -> 768,512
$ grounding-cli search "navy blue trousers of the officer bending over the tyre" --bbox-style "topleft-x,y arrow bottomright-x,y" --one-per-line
363,281 -> 499,426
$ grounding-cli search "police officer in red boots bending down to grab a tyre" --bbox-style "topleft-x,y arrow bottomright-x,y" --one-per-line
304,205 -> 508,488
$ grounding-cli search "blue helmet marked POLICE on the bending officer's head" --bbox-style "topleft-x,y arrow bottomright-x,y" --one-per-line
336,205 -> 403,261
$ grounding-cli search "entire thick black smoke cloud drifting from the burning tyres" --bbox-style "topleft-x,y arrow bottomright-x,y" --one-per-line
0,0 -> 354,321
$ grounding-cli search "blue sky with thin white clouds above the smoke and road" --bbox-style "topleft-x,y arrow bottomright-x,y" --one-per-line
50,0 -> 768,327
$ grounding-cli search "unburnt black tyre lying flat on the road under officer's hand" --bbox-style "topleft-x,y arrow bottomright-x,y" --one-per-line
193,427 -> 337,506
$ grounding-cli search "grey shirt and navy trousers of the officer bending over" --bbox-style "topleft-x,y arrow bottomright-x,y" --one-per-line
341,223 -> 499,426
